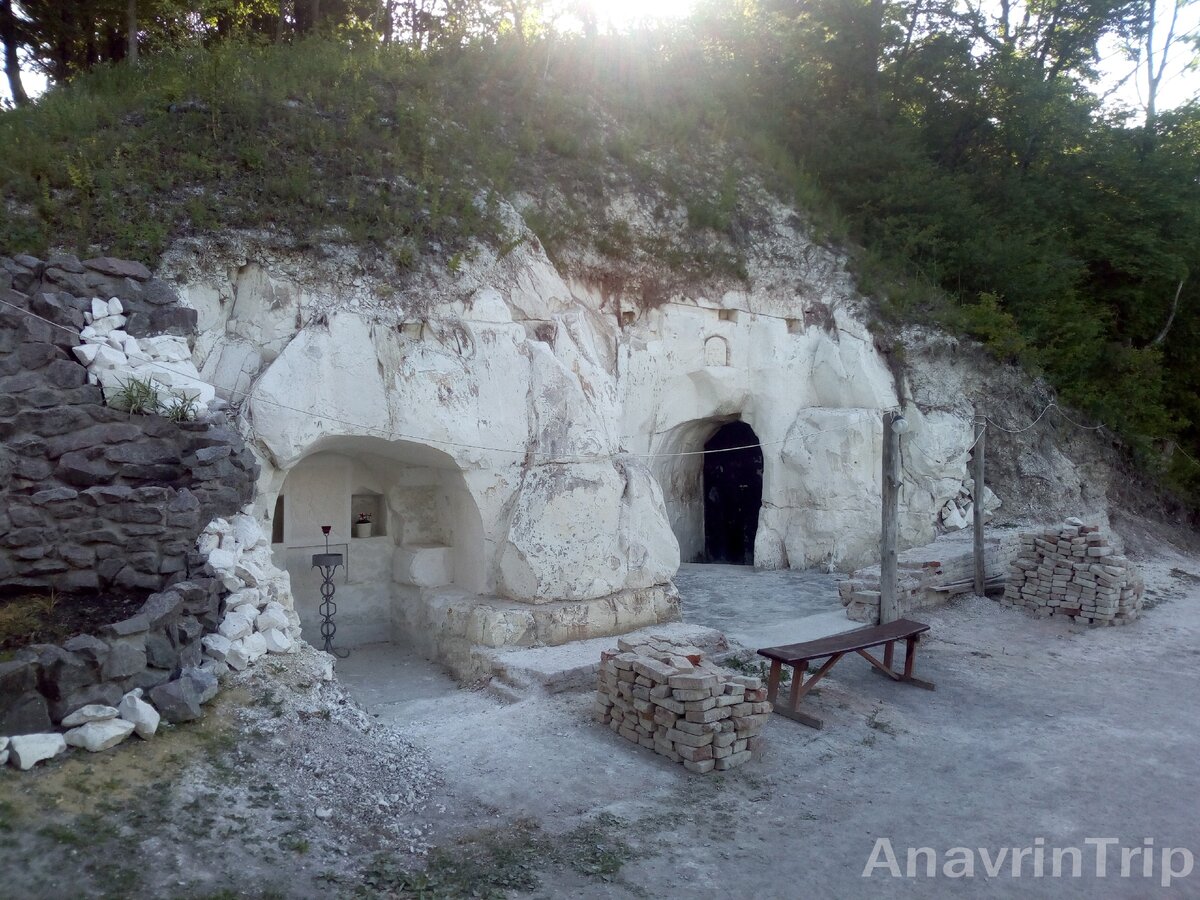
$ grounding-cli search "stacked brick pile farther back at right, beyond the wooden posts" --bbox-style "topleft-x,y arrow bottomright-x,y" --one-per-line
1001,520 -> 1145,625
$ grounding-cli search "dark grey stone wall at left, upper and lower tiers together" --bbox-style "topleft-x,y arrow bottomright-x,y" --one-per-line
0,256 -> 267,736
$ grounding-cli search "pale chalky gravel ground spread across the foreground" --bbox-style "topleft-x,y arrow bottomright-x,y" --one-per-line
0,532 -> 1200,898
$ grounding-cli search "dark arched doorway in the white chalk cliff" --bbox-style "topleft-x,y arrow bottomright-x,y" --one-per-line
703,421 -> 762,565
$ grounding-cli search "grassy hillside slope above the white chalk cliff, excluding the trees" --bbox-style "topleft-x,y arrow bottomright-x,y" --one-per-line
0,38 -> 763,300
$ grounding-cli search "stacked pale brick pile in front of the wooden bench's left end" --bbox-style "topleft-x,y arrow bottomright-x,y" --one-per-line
596,638 -> 770,774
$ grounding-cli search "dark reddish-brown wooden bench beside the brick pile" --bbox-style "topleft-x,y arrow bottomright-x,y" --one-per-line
758,619 -> 934,728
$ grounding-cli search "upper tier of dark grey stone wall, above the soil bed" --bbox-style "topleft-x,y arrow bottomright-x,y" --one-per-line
0,256 -> 257,595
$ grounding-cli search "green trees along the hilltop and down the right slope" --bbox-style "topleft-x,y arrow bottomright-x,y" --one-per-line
0,0 -> 1200,501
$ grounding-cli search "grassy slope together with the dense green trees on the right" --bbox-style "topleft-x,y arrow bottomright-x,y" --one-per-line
0,0 -> 1200,508
